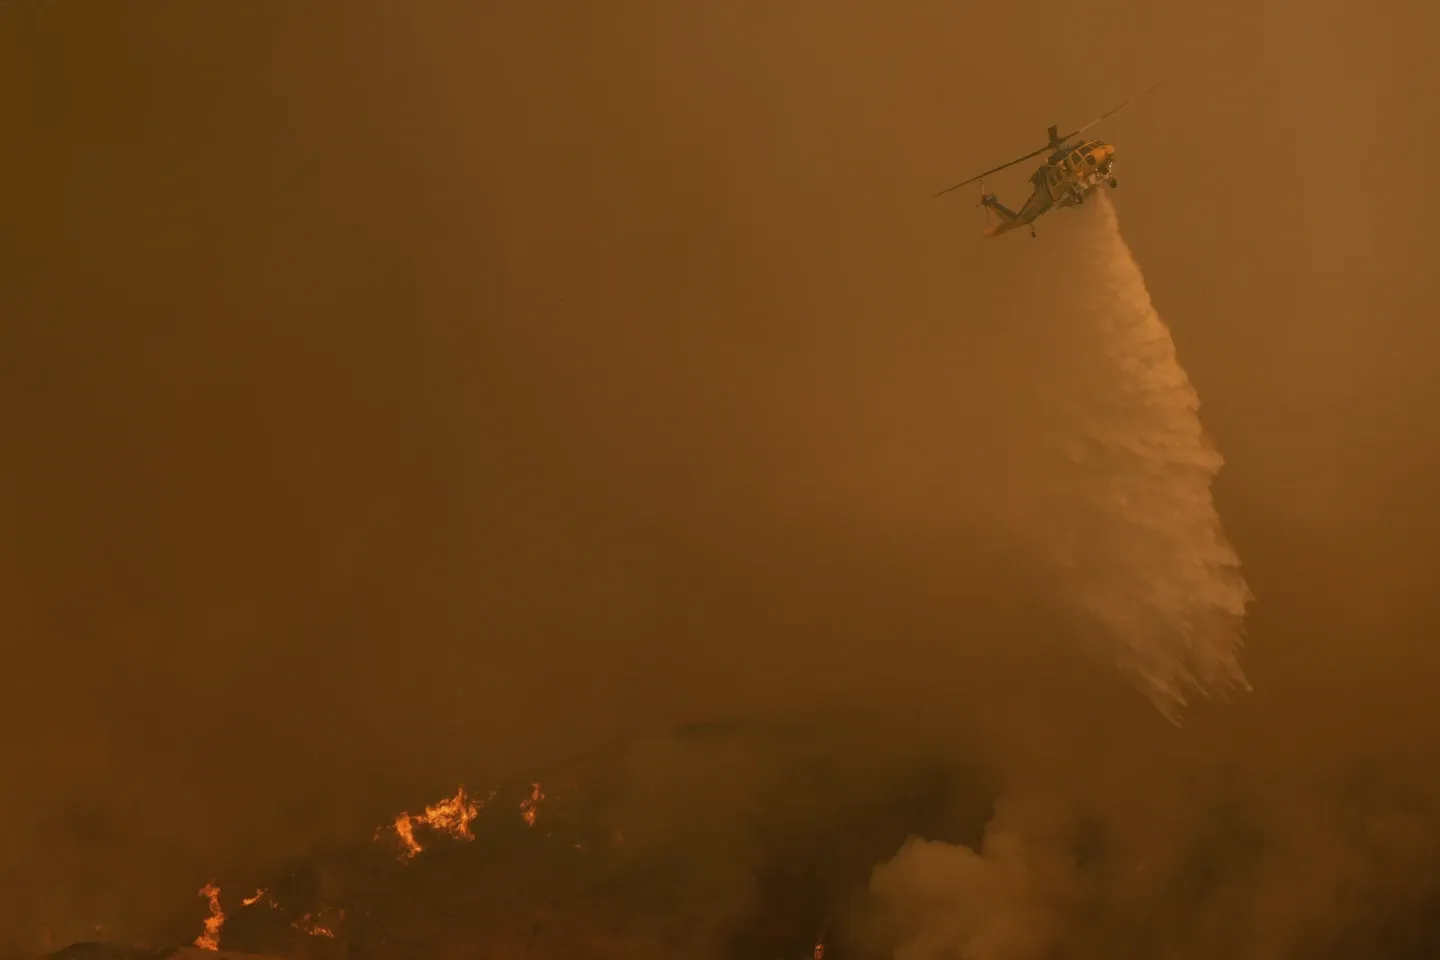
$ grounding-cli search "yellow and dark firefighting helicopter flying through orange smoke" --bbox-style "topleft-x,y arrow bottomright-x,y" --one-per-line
935,83 -> 1158,236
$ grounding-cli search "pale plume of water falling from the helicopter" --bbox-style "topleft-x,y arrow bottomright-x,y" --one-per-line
1017,191 -> 1253,723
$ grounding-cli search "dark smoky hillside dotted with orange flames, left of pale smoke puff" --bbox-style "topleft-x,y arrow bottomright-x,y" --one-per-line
42,719 -> 967,960
